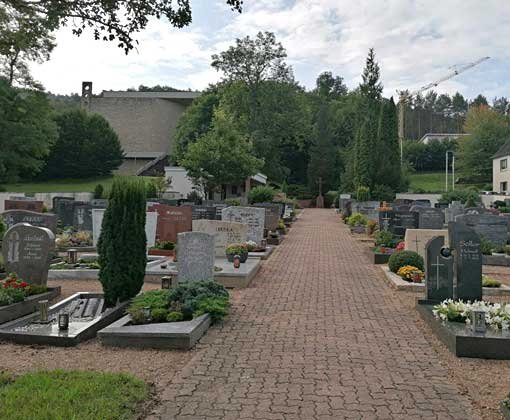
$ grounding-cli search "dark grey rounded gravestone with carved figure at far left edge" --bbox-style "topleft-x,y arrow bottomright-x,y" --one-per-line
2,223 -> 55,285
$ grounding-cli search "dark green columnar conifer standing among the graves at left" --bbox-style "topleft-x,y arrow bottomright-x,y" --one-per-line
97,178 -> 147,306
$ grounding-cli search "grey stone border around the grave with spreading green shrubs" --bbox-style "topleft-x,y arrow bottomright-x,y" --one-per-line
98,314 -> 211,350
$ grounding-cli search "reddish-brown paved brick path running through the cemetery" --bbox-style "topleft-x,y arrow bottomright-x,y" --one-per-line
150,209 -> 477,420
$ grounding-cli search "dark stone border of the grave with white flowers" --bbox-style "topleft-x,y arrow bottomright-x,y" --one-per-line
416,300 -> 510,360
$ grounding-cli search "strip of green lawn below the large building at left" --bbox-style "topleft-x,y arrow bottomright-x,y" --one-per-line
1,176 -> 157,193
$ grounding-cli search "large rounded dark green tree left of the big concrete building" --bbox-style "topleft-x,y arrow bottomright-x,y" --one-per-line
42,110 -> 124,179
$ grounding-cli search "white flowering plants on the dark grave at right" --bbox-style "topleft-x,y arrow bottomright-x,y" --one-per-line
432,299 -> 510,330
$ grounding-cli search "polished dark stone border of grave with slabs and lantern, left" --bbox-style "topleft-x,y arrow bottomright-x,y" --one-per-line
0,292 -> 129,347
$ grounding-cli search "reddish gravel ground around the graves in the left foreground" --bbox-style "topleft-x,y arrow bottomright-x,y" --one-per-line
0,280 -> 240,416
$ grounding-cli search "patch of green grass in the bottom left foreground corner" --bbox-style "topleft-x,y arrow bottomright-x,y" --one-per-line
0,370 -> 148,420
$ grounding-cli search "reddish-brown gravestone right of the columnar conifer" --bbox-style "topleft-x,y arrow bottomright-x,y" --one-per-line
149,204 -> 192,242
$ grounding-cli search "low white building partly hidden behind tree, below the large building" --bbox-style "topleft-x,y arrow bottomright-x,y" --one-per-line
165,166 -> 267,200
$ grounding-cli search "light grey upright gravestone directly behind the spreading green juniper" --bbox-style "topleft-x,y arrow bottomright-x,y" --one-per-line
177,232 -> 215,282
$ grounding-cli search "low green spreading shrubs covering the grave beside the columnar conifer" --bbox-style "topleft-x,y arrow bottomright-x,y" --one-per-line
127,281 -> 230,325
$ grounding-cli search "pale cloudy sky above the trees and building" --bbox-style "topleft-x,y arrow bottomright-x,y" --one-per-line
32,0 -> 510,100
